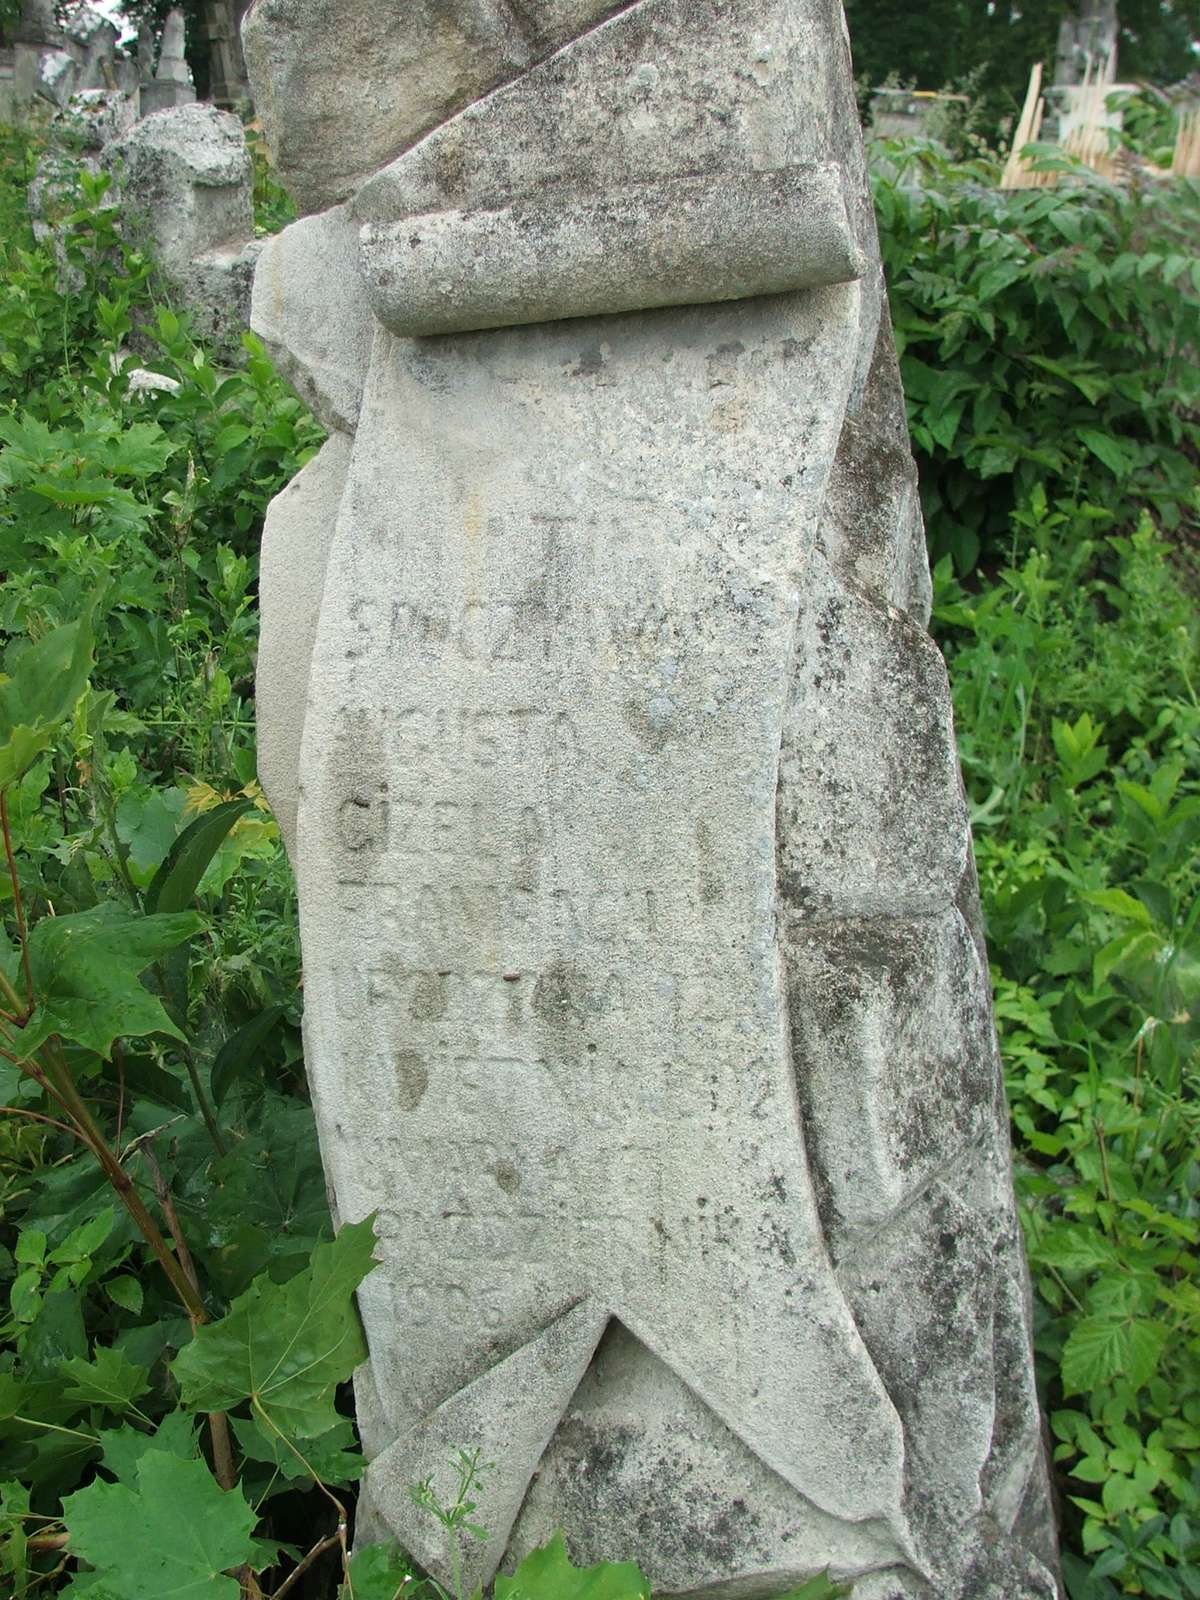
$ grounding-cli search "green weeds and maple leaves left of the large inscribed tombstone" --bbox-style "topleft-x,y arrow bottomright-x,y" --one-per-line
0,121 -> 347,1600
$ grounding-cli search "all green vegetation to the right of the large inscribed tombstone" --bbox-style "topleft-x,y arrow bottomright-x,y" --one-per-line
875,146 -> 1200,1600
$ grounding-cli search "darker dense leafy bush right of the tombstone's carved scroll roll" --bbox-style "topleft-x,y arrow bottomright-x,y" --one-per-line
875,142 -> 1200,573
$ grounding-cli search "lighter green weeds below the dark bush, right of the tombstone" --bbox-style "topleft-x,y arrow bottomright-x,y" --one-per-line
934,502 -> 1200,1600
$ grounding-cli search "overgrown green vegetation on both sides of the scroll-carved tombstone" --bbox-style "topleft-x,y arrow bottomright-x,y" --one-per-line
0,118 -> 1200,1600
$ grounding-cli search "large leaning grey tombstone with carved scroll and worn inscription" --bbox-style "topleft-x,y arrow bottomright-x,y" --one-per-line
251,0 -> 1058,1600
